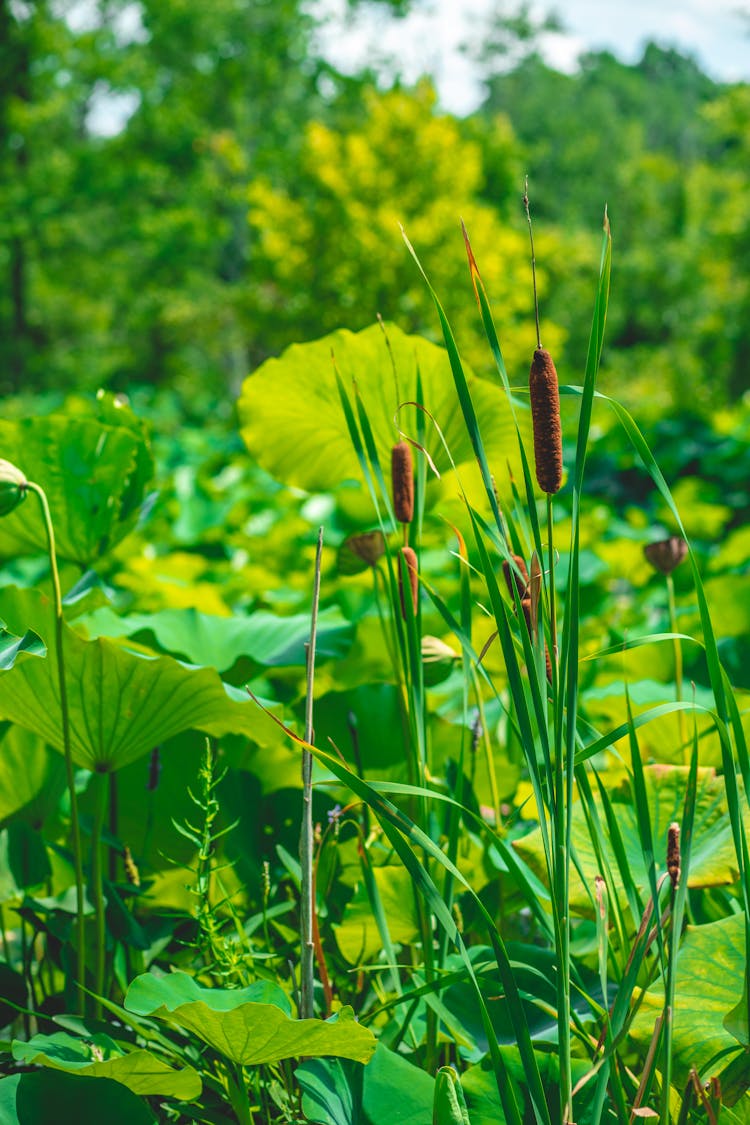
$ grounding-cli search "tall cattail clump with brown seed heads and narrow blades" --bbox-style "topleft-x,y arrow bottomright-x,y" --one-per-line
318,190 -> 750,1125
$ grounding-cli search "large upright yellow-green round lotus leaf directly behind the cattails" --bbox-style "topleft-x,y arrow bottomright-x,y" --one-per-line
238,324 -> 528,501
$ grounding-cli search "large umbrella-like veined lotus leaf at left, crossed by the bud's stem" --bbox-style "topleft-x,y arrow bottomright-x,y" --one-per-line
0,590 -> 280,772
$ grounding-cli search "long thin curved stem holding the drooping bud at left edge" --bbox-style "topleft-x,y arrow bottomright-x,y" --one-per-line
28,480 -> 85,1015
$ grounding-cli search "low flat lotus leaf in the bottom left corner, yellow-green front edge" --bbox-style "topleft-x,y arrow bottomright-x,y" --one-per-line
12,1032 -> 202,1101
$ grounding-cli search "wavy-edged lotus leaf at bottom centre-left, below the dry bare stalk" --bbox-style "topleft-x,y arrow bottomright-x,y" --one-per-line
125,972 -> 376,1067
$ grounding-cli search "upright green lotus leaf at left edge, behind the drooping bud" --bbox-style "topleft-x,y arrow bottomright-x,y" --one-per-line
0,407 -> 153,567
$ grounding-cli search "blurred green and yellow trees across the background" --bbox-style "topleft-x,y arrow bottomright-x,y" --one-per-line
0,0 -> 750,410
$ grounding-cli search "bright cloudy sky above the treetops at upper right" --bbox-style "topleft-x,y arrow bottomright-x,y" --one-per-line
311,0 -> 750,114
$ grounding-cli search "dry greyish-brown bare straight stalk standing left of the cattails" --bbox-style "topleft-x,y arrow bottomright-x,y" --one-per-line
299,528 -> 323,1019
